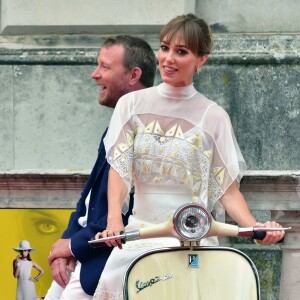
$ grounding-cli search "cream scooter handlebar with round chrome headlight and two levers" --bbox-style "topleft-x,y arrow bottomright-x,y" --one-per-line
89,203 -> 291,248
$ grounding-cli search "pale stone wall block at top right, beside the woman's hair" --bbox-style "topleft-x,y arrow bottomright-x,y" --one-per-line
196,0 -> 300,33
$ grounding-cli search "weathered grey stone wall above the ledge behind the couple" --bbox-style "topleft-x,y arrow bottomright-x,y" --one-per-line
0,0 -> 300,171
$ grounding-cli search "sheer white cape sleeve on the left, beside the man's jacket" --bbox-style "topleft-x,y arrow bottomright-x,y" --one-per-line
104,93 -> 135,214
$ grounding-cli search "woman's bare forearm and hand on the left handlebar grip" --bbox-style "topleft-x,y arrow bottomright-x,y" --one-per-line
96,168 -> 128,249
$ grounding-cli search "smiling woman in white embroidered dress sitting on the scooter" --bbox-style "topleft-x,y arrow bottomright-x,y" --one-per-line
94,14 -> 284,300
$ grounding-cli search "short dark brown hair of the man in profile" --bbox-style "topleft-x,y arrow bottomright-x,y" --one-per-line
102,35 -> 157,87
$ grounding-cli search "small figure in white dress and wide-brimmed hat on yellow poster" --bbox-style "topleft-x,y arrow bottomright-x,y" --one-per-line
13,240 -> 44,300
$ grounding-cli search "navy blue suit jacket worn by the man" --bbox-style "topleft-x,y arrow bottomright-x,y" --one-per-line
62,129 -> 133,295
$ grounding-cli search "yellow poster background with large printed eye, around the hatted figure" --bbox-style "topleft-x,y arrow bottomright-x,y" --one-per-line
0,209 -> 73,300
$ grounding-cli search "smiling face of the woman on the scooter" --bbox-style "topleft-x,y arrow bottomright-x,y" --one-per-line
158,36 -> 207,87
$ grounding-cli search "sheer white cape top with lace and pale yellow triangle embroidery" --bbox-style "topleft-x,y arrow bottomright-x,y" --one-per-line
104,83 -> 246,220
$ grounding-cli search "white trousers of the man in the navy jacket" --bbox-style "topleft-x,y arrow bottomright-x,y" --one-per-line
45,262 -> 93,300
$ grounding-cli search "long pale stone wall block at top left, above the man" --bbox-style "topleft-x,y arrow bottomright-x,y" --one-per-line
1,0 -> 195,35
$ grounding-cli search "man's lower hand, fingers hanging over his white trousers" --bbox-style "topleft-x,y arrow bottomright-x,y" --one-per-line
51,256 -> 76,288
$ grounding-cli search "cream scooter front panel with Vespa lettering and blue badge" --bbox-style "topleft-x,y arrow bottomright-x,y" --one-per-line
124,247 -> 260,300
